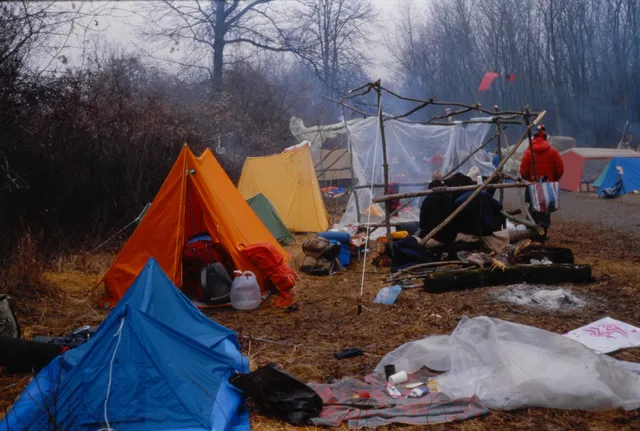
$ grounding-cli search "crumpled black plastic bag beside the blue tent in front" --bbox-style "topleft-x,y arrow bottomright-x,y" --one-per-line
229,364 -> 322,426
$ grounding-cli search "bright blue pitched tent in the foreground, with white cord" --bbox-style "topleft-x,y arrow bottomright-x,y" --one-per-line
0,259 -> 250,431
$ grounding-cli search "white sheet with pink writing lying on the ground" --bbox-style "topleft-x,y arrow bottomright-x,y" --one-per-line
564,317 -> 640,353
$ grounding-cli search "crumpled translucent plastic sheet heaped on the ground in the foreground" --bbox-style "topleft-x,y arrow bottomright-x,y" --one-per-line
376,317 -> 640,410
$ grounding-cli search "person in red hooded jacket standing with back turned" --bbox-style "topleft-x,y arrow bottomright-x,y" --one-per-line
520,124 -> 564,237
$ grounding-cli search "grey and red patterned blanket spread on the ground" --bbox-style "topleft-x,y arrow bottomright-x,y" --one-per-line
309,370 -> 489,429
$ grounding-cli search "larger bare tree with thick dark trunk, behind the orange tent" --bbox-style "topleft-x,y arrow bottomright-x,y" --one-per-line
143,0 -> 296,92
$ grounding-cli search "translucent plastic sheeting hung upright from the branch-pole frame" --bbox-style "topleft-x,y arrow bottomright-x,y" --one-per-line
289,117 -> 493,226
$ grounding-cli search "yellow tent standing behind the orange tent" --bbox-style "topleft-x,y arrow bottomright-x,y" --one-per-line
238,145 -> 329,232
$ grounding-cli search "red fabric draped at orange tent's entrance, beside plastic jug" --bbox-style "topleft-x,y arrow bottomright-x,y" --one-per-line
242,243 -> 298,307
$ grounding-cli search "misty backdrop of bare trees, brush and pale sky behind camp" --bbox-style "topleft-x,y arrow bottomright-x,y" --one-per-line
0,0 -> 640,266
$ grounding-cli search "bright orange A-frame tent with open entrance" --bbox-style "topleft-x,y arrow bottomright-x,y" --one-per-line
102,145 -> 289,307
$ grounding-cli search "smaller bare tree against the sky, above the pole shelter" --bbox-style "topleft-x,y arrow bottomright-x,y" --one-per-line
293,0 -> 376,95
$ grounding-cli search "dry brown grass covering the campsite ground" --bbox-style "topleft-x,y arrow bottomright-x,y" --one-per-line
0,223 -> 640,431
